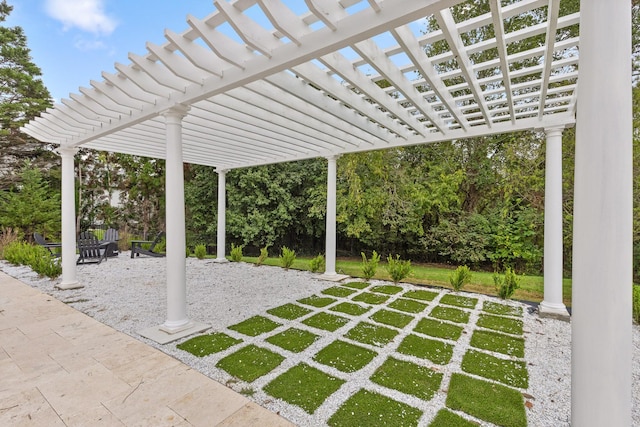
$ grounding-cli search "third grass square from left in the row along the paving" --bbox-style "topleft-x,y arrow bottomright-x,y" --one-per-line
264,363 -> 345,414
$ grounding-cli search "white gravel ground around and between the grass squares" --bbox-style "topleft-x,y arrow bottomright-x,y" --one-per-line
0,252 -> 640,427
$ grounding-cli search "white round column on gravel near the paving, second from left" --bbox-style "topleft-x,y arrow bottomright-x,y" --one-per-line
161,106 -> 189,333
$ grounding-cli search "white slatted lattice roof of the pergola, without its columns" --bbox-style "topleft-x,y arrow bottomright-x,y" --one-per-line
23,0 -> 579,169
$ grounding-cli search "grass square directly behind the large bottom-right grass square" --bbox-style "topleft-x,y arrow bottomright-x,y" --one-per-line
462,350 -> 529,388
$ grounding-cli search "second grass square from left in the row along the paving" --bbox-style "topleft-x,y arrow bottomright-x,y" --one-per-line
216,344 -> 285,382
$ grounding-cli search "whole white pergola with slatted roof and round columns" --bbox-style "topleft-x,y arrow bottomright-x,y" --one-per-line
18,0 -> 632,426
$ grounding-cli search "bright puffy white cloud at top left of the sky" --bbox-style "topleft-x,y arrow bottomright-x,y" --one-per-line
45,0 -> 117,35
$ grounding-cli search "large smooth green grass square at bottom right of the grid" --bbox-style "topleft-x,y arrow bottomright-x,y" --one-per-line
446,373 -> 527,427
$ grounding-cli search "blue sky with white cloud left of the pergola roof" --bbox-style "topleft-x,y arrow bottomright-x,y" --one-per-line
4,0 -> 230,102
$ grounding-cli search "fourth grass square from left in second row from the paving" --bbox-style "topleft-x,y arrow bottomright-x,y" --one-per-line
371,357 -> 444,400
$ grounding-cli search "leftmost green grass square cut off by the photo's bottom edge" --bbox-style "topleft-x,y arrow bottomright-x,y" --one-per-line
328,389 -> 422,427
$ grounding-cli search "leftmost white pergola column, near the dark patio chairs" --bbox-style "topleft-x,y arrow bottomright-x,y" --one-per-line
56,146 -> 84,289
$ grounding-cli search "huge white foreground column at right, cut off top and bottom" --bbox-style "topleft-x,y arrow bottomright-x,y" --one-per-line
571,0 -> 633,427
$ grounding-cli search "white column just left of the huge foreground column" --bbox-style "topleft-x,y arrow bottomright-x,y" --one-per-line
538,128 -> 569,320
